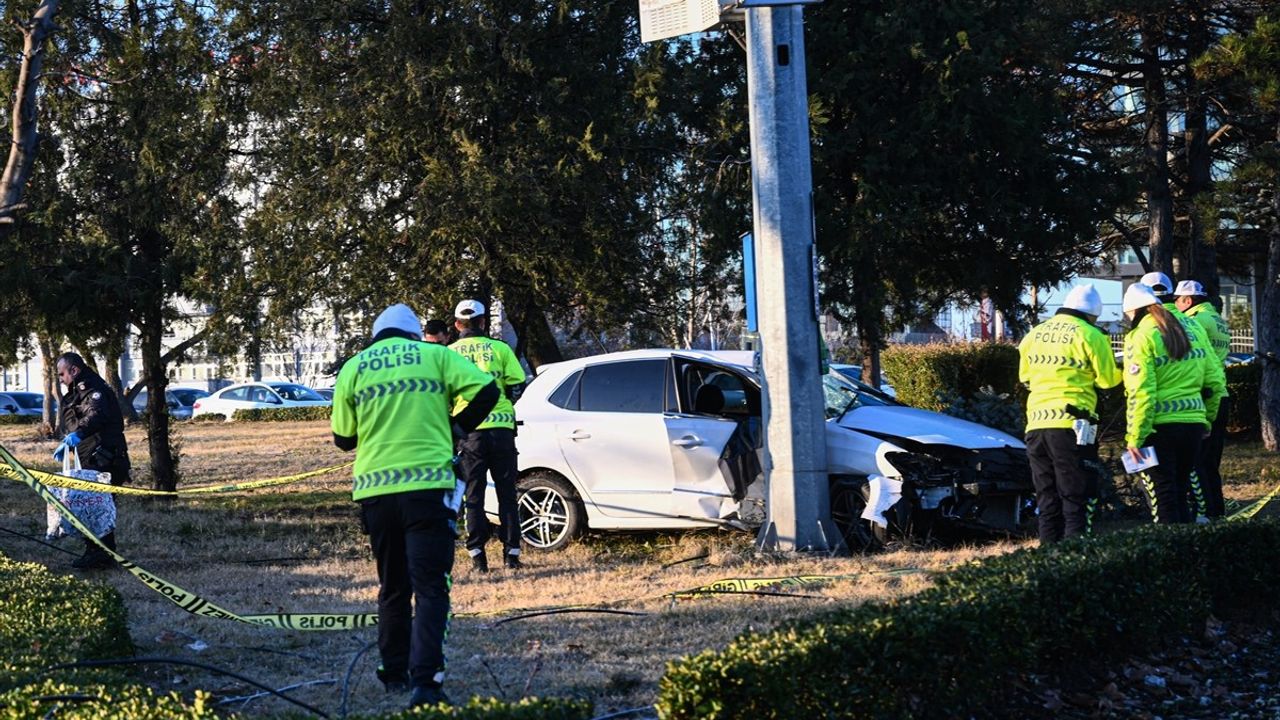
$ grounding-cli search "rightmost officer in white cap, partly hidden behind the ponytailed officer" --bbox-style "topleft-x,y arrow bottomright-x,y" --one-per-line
1174,281 -> 1231,518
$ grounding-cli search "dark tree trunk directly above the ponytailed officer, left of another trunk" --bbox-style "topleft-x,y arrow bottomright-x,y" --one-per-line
1142,17 -> 1174,274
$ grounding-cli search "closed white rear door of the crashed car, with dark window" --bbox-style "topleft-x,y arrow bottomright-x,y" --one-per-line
556,357 -> 675,518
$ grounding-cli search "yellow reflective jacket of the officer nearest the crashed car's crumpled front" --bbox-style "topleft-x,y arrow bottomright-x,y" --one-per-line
1018,310 -> 1121,430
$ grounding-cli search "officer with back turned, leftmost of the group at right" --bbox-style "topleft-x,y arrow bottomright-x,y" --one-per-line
1018,284 -> 1120,543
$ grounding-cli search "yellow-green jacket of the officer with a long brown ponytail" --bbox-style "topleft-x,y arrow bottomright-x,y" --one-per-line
1124,313 -> 1226,447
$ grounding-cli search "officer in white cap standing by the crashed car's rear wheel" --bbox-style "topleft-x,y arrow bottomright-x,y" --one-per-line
449,300 -> 525,573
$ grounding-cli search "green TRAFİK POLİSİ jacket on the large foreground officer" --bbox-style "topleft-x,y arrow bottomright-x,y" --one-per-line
330,337 -> 492,500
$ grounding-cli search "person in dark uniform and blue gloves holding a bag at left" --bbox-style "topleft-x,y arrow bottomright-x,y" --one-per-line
54,352 -> 132,570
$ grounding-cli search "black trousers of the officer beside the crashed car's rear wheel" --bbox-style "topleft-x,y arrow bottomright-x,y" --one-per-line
458,428 -> 520,555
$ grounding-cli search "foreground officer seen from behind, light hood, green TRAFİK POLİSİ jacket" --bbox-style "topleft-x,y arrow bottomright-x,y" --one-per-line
332,305 -> 499,707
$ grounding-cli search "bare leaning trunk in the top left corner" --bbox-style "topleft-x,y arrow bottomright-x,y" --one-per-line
0,0 -> 59,223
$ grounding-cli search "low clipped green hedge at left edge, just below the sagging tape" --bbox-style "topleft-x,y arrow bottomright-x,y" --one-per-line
0,555 -> 133,691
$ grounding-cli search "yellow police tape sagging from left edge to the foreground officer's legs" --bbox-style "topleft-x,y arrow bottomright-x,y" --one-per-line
0,446 -> 378,630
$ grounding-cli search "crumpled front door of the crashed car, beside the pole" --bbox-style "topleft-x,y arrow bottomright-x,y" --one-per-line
664,357 -> 760,518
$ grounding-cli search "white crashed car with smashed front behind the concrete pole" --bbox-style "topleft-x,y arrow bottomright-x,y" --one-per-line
485,350 -> 1034,550
